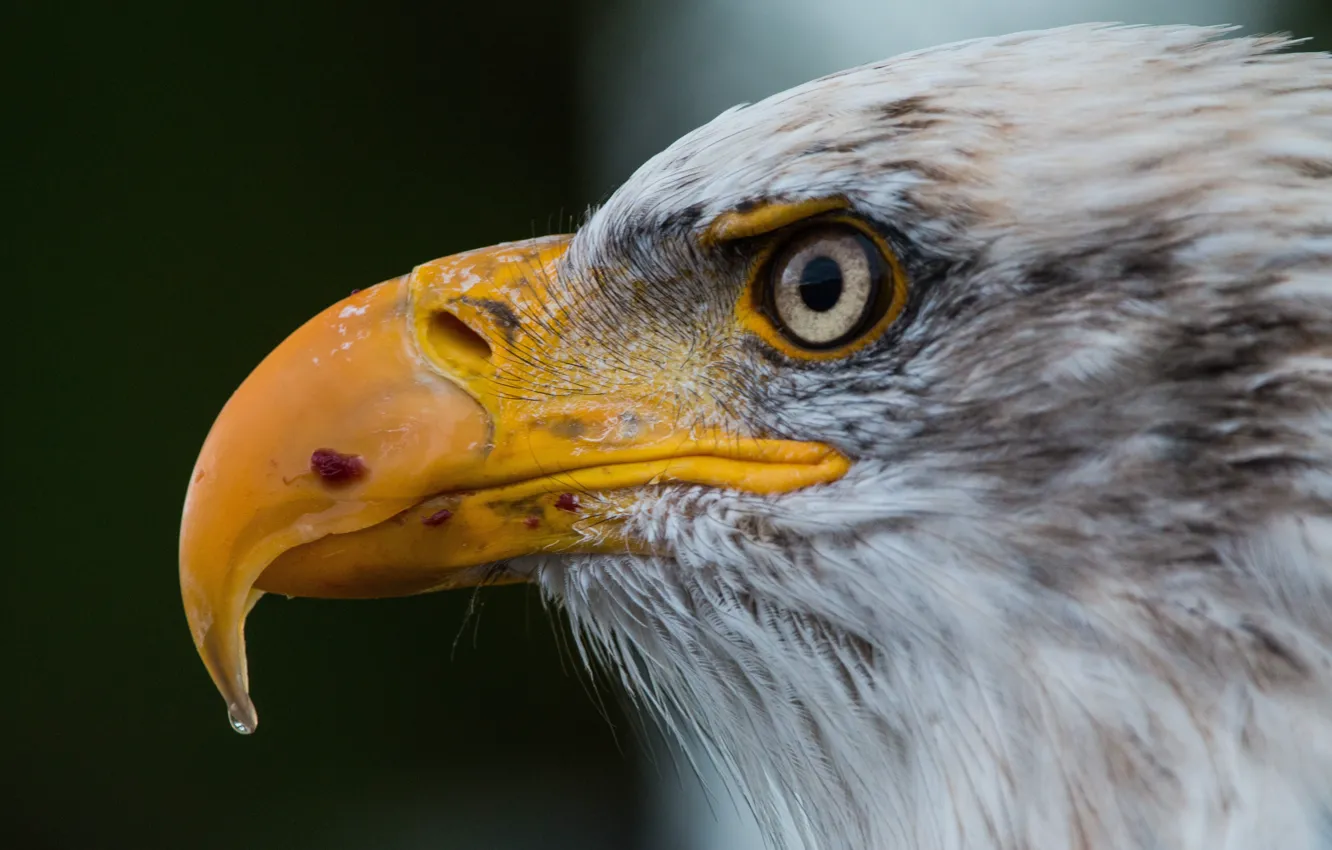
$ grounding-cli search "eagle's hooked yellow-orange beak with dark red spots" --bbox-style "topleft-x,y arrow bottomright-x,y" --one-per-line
180,237 -> 847,731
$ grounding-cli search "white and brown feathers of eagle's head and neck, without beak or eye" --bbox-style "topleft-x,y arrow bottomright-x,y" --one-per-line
500,27 -> 1332,850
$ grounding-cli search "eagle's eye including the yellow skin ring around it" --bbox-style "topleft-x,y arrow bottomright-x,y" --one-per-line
742,217 -> 907,360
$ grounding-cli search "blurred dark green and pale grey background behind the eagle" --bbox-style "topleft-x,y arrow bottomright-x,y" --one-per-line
10,0 -> 1332,850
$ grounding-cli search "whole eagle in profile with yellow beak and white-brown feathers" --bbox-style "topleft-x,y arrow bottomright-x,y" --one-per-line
180,25 -> 1332,850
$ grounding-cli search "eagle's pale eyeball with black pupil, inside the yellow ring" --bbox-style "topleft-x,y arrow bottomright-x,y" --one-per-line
757,224 -> 903,352
